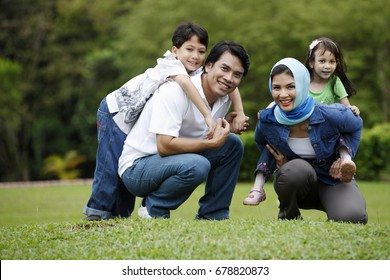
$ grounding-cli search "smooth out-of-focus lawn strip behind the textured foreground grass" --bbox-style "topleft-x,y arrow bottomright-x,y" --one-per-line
0,182 -> 390,226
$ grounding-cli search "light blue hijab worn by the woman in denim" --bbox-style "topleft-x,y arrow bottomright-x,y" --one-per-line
269,57 -> 315,125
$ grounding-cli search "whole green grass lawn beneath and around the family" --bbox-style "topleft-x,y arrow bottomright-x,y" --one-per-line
0,182 -> 390,260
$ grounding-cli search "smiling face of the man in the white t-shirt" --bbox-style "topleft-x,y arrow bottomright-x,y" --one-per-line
202,52 -> 244,102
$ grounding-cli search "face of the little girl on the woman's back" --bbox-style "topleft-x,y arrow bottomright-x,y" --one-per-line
310,49 -> 337,80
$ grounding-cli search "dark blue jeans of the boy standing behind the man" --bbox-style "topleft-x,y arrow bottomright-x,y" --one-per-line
83,98 -> 135,219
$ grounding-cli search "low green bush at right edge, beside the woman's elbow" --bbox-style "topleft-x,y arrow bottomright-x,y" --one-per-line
355,123 -> 390,180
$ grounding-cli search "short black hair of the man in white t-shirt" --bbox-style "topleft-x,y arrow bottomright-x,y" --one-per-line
205,41 -> 250,76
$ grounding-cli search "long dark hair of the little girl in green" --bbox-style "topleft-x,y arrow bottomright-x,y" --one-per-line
305,37 -> 356,97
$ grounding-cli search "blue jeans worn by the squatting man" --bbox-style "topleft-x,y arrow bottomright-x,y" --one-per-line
122,134 -> 244,220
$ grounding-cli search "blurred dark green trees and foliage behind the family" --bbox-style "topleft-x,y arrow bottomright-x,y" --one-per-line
0,0 -> 390,182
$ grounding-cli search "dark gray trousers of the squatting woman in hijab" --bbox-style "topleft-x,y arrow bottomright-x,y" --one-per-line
274,159 -> 368,224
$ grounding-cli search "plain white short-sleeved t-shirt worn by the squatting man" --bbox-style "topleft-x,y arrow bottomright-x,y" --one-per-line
118,73 -> 231,176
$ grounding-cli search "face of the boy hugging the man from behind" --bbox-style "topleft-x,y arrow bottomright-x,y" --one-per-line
172,35 -> 206,73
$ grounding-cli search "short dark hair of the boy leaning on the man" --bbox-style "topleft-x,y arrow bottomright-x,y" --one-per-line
172,22 -> 209,49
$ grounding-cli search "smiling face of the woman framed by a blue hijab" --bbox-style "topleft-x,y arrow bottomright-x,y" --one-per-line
272,73 -> 296,112
